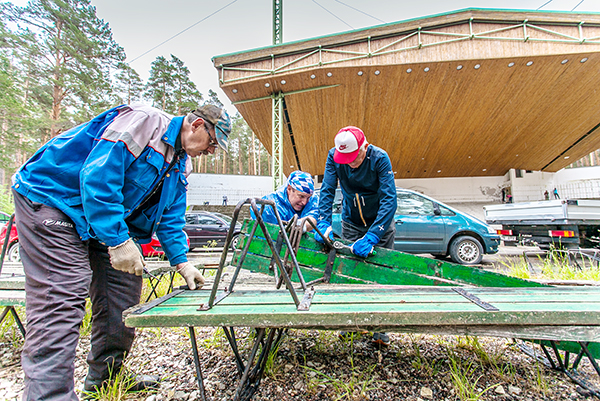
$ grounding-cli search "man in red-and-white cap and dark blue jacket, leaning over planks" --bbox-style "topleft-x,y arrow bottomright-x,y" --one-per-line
315,126 -> 398,345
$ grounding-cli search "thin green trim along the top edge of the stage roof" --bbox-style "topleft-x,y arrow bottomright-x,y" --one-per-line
211,8 -> 600,62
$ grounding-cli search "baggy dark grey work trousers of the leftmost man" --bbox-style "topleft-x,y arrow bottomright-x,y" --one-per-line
13,191 -> 142,401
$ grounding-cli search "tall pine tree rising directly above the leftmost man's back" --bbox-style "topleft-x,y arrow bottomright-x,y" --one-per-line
3,0 -> 125,136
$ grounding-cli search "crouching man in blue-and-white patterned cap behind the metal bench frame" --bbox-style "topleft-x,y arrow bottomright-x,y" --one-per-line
252,170 -> 319,232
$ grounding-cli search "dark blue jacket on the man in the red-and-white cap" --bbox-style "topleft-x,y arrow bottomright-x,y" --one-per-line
319,145 -> 398,239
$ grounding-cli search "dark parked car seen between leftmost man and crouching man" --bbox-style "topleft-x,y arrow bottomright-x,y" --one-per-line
183,211 -> 242,251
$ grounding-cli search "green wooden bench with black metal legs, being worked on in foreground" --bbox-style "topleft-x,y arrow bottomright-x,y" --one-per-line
123,203 -> 600,400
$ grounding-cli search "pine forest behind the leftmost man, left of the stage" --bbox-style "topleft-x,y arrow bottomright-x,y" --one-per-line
0,0 -> 270,211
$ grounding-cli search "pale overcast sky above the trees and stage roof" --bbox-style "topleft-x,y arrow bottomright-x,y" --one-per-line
13,0 -> 600,112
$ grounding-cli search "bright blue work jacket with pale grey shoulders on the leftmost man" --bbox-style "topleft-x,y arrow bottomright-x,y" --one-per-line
13,105 -> 191,265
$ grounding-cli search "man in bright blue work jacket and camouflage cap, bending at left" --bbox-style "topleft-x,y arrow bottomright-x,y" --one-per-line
13,105 -> 231,400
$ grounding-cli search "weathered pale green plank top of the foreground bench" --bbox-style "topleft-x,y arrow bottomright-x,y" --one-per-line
126,288 -> 600,332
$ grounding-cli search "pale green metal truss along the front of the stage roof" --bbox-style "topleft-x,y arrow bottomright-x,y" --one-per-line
218,18 -> 600,84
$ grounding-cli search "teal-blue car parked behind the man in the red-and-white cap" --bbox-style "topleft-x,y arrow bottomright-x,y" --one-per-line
332,188 -> 500,265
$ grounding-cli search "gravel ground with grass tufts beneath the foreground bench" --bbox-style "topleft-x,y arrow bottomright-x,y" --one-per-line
0,247 -> 600,401
